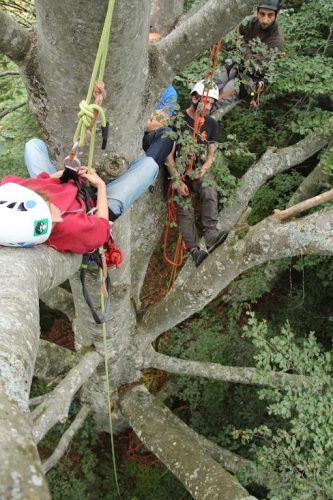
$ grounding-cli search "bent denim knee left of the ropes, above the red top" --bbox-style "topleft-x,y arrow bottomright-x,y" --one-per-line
24,138 -> 57,177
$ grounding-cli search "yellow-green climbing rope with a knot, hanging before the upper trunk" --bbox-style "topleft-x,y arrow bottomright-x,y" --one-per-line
73,0 -> 116,171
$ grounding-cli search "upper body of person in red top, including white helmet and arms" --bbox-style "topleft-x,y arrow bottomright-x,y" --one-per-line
0,167 -> 110,254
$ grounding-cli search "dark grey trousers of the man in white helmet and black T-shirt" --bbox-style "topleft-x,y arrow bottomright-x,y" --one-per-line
176,172 -> 218,250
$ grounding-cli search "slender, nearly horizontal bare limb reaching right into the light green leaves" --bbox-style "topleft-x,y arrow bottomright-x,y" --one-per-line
145,348 -> 310,386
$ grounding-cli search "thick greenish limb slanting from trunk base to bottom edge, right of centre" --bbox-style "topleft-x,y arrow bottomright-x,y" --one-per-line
120,386 -> 254,500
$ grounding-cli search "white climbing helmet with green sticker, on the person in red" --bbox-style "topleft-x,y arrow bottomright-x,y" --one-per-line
0,182 -> 52,247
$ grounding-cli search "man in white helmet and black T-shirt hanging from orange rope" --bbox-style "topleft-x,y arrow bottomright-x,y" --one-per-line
166,80 -> 228,266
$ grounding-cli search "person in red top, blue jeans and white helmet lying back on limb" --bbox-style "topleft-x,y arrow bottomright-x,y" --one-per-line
0,138 -> 159,254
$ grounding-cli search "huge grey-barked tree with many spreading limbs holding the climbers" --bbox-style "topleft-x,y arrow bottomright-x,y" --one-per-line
0,0 -> 333,499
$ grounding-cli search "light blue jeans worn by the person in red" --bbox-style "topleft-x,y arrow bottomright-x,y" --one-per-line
24,139 -> 158,216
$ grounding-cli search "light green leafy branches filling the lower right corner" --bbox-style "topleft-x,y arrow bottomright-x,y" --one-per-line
239,314 -> 333,500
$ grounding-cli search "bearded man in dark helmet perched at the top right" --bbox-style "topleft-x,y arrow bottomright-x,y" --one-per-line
213,0 -> 284,111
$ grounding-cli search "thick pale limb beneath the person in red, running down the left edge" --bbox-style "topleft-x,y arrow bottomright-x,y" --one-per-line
0,245 -> 80,500
